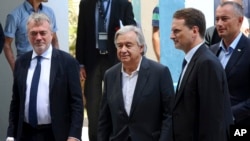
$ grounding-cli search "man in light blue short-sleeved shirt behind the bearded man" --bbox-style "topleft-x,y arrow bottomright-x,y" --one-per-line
4,0 -> 59,71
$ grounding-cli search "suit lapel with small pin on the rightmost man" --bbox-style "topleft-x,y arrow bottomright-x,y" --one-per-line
225,35 -> 246,76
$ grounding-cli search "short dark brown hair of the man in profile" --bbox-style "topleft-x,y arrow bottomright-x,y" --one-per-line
173,8 -> 206,38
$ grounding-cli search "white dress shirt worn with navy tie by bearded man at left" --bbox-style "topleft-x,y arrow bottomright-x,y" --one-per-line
24,45 -> 52,125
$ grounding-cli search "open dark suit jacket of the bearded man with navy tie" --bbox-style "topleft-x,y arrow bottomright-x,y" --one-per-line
7,49 -> 83,141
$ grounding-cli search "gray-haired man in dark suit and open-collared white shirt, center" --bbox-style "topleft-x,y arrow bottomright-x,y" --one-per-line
98,26 -> 174,141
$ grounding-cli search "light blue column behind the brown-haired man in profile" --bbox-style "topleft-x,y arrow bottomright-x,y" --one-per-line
159,0 -> 185,85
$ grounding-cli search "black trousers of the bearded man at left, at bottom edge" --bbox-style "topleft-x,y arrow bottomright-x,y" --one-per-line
20,122 -> 55,141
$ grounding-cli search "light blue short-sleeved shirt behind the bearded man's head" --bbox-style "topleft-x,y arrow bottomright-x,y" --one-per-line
4,0 -> 57,56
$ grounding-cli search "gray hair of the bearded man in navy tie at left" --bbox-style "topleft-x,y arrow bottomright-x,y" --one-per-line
26,12 -> 52,31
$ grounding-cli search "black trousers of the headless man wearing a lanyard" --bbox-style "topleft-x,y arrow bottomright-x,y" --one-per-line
84,54 -> 112,141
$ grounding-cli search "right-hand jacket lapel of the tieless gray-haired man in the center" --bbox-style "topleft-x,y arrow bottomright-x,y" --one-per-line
130,57 -> 149,116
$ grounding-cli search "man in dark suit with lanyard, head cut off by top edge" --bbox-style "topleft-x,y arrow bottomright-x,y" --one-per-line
76,0 -> 136,141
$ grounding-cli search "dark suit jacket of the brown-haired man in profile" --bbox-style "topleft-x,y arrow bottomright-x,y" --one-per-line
173,44 -> 232,141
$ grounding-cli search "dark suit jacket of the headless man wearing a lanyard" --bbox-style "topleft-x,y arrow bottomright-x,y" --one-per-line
76,0 -> 136,71
